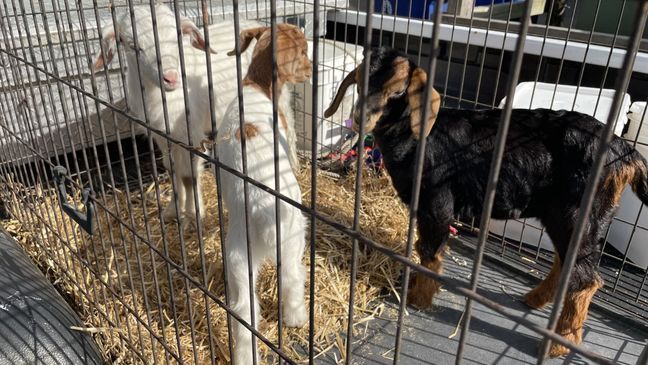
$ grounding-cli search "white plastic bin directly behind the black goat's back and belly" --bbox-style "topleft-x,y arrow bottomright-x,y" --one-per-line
489,82 -> 632,252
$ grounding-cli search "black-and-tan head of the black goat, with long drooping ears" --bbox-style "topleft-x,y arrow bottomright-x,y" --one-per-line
324,48 -> 441,139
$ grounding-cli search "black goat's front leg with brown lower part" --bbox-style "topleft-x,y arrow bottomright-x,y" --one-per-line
407,208 -> 451,308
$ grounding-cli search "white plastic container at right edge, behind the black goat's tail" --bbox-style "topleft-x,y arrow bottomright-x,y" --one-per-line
607,102 -> 648,268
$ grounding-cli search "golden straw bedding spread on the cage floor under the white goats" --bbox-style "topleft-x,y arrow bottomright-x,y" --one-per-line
5,164 -> 416,364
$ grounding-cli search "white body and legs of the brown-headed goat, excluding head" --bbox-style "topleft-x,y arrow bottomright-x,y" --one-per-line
218,86 -> 307,365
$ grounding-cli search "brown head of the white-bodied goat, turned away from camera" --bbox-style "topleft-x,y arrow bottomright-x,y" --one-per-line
228,24 -> 313,84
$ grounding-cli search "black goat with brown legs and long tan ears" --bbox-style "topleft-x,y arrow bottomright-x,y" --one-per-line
325,48 -> 648,357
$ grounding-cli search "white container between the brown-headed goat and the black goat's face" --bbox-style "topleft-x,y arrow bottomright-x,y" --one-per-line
293,39 -> 363,157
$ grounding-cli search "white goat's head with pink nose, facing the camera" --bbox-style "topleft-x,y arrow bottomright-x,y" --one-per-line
93,5 -> 213,91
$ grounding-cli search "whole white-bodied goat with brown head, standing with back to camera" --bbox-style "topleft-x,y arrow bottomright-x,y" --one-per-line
217,24 -> 312,365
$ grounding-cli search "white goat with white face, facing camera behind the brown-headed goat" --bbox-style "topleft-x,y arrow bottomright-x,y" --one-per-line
94,4 -> 297,220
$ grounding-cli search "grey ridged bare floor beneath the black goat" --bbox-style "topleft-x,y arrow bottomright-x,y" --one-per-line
328,237 -> 648,364
